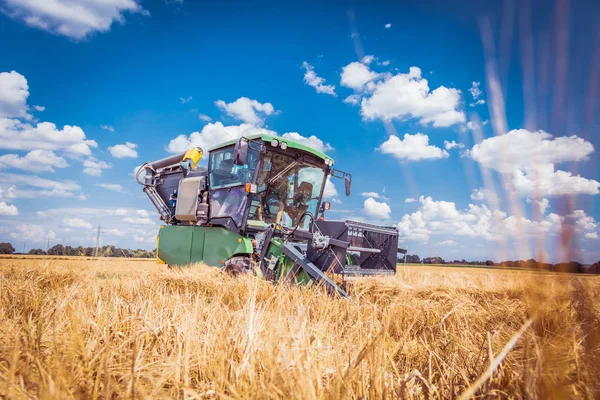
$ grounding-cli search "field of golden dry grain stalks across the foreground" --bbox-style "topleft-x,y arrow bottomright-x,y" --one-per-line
0,258 -> 600,399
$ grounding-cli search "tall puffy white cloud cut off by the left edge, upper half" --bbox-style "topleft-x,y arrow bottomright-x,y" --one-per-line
0,71 -> 31,119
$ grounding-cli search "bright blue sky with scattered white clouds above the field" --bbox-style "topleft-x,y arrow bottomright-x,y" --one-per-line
0,0 -> 600,262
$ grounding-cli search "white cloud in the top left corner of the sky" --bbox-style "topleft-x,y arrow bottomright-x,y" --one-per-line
4,0 -> 148,40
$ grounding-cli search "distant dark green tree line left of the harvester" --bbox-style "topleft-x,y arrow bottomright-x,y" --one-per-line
0,242 -> 155,258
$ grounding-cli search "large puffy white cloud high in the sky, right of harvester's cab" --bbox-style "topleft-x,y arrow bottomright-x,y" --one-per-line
341,62 -> 466,127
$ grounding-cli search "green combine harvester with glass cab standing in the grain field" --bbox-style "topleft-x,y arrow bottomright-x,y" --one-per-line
136,135 -> 406,297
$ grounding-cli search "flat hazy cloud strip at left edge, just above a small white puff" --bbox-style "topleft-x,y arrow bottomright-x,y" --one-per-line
0,172 -> 81,198
